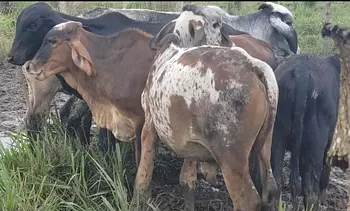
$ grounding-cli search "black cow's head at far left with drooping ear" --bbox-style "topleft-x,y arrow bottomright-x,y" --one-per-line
8,3 -> 59,65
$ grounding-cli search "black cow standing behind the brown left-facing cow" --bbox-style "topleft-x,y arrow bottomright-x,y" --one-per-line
8,2 -> 176,160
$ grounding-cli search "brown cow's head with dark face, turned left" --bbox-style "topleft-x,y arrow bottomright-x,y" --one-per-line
24,21 -> 96,80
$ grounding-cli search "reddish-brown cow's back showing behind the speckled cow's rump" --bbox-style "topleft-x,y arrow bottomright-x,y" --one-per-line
229,34 -> 277,70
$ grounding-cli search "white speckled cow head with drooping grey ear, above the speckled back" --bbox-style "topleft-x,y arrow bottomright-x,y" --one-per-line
150,11 -> 232,49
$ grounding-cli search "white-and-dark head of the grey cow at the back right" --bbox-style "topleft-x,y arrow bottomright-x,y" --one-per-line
259,2 -> 298,53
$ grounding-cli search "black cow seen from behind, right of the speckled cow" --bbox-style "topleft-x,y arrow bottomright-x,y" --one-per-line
271,54 -> 340,210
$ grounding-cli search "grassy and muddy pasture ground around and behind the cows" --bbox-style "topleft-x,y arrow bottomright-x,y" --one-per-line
0,2 -> 350,211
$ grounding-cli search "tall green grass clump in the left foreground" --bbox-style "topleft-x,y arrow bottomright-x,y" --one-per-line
0,116 -> 160,211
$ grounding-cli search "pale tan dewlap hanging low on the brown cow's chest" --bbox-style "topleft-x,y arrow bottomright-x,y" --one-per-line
91,105 -> 135,142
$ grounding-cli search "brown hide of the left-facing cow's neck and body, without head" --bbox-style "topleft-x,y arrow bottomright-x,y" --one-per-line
63,30 -> 155,141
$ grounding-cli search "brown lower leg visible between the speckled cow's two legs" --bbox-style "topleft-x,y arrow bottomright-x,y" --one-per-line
180,159 -> 197,211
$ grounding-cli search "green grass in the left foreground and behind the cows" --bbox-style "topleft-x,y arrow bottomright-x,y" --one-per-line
0,2 -> 350,211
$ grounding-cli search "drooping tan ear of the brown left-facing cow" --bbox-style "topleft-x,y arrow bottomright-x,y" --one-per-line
69,40 -> 96,77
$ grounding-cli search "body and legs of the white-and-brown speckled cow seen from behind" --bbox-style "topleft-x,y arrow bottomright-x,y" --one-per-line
135,33 -> 278,211
